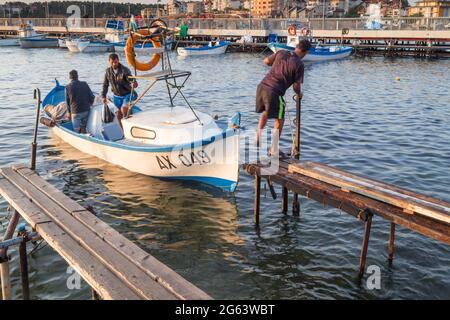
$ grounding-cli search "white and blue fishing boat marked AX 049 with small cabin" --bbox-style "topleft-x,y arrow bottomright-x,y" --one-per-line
42,24 -> 240,191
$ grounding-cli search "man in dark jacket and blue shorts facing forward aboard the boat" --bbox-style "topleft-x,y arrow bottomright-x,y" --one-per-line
102,53 -> 137,126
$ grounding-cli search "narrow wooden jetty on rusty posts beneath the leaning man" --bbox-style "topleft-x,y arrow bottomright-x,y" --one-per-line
245,158 -> 450,276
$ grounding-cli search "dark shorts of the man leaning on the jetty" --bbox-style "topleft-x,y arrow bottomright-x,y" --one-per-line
256,85 -> 285,119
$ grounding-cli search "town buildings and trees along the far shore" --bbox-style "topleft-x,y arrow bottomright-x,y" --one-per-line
0,0 -> 450,19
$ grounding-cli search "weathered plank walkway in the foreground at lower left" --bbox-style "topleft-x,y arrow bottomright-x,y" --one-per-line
0,165 -> 210,300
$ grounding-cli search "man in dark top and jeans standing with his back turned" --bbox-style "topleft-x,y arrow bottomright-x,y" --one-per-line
66,70 -> 95,133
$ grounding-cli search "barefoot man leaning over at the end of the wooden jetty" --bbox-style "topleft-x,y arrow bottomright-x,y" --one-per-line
256,40 -> 311,152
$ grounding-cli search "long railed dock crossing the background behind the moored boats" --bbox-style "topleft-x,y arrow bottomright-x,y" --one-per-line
0,17 -> 450,58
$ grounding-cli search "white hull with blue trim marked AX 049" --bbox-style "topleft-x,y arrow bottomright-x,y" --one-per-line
53,126 -> 239,192
